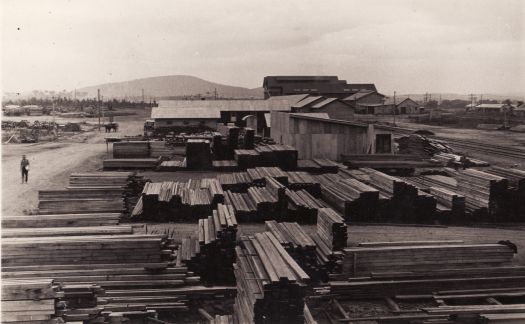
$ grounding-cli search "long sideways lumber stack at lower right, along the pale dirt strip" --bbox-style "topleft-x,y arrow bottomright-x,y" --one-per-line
343,243 -> 515,277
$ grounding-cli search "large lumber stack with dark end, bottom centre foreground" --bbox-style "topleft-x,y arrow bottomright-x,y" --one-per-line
234,232 -> 310,323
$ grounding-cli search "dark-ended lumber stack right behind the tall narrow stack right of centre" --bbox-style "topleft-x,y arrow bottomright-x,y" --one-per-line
317,175 -> 379,222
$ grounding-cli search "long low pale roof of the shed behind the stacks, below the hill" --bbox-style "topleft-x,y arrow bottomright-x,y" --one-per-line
158,94 -> 308,111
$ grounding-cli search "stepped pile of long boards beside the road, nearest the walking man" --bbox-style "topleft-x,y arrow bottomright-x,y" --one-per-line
38,172 -> 145,215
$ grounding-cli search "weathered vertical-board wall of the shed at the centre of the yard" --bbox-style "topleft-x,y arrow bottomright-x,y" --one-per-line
271,111 -> 393,160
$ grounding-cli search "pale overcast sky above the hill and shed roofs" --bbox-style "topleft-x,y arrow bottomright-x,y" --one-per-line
0,0 -> 525,94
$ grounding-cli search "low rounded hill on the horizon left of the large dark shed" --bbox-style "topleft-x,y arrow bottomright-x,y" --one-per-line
76,75 -> 263,100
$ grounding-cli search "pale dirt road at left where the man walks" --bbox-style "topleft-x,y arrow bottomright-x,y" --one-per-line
2,116 -> 145,215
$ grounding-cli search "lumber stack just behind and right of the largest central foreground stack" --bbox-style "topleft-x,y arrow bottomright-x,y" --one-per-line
265,221 -> 324,281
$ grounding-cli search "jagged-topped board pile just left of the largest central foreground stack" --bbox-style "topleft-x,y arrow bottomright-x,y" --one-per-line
177,204 -> 237,285
